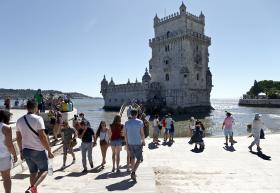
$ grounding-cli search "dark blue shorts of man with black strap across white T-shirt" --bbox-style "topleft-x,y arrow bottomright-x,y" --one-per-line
23,148 -> 48,174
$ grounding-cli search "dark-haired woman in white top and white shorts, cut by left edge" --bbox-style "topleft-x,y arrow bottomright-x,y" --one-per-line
0,110 -> 17,193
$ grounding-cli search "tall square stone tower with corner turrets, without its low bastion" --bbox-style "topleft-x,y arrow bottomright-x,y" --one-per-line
149,3 -> 212,108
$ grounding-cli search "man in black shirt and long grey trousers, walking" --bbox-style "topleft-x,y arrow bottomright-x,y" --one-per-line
79,121 -> 96,172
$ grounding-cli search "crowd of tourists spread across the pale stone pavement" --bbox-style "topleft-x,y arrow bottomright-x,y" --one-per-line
0,97 -> 263,193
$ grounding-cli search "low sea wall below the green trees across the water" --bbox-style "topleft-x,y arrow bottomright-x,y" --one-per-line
238,99 -> 280,108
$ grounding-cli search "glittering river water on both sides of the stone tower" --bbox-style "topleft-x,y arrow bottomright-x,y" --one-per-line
0,99 -> 280,137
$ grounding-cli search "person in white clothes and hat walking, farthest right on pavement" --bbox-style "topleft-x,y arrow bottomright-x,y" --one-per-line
248,113 -> 264,152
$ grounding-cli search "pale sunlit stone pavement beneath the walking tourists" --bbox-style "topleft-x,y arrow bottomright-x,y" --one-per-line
0,134 -> 280,193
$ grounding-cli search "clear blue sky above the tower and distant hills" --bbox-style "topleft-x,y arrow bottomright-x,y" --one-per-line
0,0 -> 280,98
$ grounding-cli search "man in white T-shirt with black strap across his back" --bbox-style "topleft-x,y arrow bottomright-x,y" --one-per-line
16,100 -> 54,193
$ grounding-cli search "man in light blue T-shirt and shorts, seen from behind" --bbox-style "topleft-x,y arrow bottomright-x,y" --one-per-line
124,109 -> 145,181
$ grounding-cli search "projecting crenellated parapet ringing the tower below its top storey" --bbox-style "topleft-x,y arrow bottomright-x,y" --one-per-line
149,29 -> 211,46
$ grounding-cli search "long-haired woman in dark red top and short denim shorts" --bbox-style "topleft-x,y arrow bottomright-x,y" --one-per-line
110,115 -> 123,172
